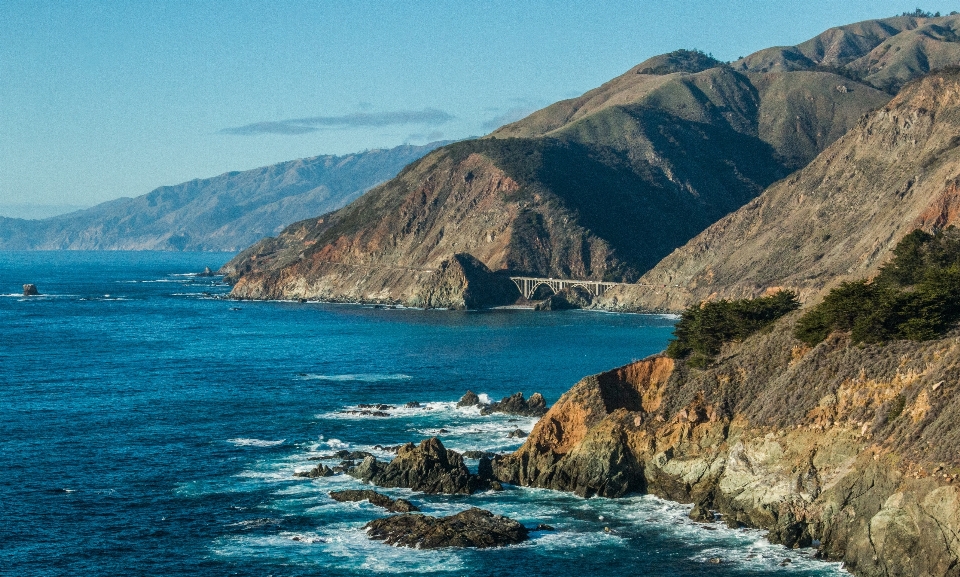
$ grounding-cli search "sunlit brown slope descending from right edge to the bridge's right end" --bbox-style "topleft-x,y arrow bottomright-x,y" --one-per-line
603,70 -> 960,310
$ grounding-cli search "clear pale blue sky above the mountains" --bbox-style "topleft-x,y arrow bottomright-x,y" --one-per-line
0,0 -> 960,206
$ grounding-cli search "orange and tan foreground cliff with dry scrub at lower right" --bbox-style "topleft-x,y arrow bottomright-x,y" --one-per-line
493,313 -> 960,577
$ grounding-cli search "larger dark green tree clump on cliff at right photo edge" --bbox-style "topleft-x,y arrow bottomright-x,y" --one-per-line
794,226 -> 960,346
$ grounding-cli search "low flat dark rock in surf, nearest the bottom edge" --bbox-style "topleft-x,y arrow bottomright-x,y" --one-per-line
364,507 -> 529,549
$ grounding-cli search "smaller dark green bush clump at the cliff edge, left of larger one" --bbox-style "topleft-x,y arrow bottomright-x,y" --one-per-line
667,291 -> 800,368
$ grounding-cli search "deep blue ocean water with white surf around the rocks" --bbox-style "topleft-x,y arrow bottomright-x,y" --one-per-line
0,252 -> 843,577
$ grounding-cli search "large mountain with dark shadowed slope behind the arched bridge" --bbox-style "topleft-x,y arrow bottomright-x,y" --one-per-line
224,16 -> 960,306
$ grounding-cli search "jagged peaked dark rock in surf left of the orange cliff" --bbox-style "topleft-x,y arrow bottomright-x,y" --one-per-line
348,437 -> 499,495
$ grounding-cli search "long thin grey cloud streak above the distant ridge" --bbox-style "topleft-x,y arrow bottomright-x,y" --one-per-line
220,108 -> 454,136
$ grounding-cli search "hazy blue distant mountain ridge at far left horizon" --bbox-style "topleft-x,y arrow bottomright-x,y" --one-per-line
0,142 -> 446,251
